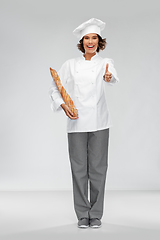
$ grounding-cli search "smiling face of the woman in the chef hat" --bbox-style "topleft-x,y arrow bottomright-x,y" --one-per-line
83,33 -> 99,54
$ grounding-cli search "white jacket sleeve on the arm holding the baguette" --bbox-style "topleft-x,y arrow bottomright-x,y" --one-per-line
49,61 -> 69,112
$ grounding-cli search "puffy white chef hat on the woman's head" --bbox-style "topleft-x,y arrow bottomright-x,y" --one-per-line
73,18 -> 106,40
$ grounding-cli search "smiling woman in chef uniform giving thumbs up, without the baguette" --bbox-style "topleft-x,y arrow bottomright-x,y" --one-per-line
49,18 -> 119,228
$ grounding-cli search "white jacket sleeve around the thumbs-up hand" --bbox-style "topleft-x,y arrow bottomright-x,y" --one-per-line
103,58 -> 119,85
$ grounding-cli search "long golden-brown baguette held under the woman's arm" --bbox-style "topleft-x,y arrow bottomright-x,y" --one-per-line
50,68 -> 78,117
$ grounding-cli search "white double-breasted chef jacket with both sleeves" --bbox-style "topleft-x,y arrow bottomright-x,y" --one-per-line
49,53 -> 119,133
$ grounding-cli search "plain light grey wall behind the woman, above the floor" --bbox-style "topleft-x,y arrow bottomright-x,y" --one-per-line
0,0 -> 160,190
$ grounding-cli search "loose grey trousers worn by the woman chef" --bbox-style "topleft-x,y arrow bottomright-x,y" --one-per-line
68,129 -> 109,219
